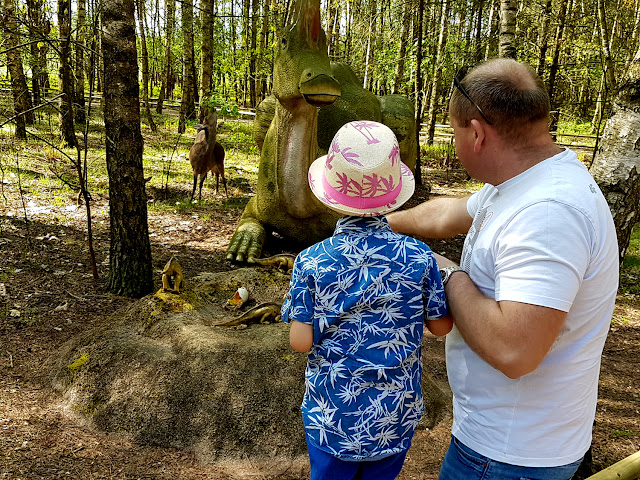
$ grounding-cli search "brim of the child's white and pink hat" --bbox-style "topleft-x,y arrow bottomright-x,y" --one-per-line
309,155 -> 416,217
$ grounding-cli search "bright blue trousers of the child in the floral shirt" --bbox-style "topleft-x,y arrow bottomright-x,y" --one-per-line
307,438 -> 407,480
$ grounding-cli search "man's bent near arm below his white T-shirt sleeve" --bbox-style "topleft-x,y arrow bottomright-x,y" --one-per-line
436,254 -> 567,378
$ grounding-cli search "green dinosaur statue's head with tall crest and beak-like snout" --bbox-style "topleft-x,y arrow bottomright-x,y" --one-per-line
273,0 -> 340,107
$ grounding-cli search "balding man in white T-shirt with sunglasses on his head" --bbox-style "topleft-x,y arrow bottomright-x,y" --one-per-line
388,59 -> 618,480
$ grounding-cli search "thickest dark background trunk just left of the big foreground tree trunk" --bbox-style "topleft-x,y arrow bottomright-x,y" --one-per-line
58,0 -> 77,147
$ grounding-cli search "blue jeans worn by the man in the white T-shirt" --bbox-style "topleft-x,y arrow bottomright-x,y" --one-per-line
438,437 -> 582,480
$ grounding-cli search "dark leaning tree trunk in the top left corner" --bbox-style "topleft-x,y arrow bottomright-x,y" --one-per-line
3,0 -> 33,139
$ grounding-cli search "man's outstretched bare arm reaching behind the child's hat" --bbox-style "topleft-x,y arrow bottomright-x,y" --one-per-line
387,197 -> 473,238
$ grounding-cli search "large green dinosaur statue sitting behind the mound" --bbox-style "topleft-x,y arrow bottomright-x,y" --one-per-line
227,0 -> 416,263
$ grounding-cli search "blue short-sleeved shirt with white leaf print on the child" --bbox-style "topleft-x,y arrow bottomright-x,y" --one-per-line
282,216 -> 448,460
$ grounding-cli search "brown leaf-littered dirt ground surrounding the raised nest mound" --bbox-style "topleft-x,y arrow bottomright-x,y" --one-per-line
0,173 -> 640,480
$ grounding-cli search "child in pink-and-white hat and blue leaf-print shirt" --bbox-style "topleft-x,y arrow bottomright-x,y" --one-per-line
282,121 -> 453,480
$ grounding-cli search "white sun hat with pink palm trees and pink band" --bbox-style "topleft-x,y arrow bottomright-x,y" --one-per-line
309,120 -> 415,217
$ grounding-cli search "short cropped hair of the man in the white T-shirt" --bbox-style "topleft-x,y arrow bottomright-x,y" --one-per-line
449,58 -> 550,142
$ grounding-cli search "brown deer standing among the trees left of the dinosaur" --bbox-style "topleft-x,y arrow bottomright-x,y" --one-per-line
189,110 -> 229,200
